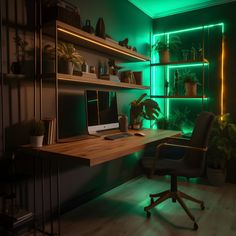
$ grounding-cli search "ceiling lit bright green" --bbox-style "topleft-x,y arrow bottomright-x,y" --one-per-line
128,0 -> 236,19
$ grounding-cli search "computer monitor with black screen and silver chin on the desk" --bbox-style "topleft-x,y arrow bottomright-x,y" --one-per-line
85,90 -> 119,134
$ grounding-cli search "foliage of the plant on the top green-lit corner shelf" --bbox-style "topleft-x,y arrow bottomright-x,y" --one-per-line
152,35 -> 182,53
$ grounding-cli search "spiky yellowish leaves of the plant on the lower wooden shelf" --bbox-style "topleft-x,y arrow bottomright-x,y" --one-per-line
57,42 -> 84,65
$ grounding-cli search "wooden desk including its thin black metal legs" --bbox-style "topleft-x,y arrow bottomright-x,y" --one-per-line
22,129 -> 180,235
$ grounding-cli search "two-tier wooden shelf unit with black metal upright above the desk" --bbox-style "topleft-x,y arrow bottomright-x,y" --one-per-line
42,20 -> 150,140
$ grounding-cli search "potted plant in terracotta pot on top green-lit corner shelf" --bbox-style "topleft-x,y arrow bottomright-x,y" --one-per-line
152,35 -> 181,63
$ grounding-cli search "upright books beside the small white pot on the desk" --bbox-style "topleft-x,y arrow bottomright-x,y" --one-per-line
43,118 -> 56,145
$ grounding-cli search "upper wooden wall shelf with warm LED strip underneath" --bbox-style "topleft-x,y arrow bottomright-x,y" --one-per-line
43,21 -> 150,62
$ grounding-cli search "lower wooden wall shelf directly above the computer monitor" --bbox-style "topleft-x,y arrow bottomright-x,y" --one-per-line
57,74 -> 149,90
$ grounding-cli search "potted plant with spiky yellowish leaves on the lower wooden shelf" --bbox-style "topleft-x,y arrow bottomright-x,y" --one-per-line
57,42 -> 84,75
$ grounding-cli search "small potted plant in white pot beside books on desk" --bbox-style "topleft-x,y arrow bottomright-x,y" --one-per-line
30,120 -> 45,147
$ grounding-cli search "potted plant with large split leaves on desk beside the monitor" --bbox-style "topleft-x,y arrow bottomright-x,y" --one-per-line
130,93 -> 160,129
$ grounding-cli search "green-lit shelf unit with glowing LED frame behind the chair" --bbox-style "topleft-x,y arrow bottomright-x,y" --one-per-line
151,23 -> 223,132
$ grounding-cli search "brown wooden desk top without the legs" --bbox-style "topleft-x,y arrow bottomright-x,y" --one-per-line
24,129 -> 180,166
